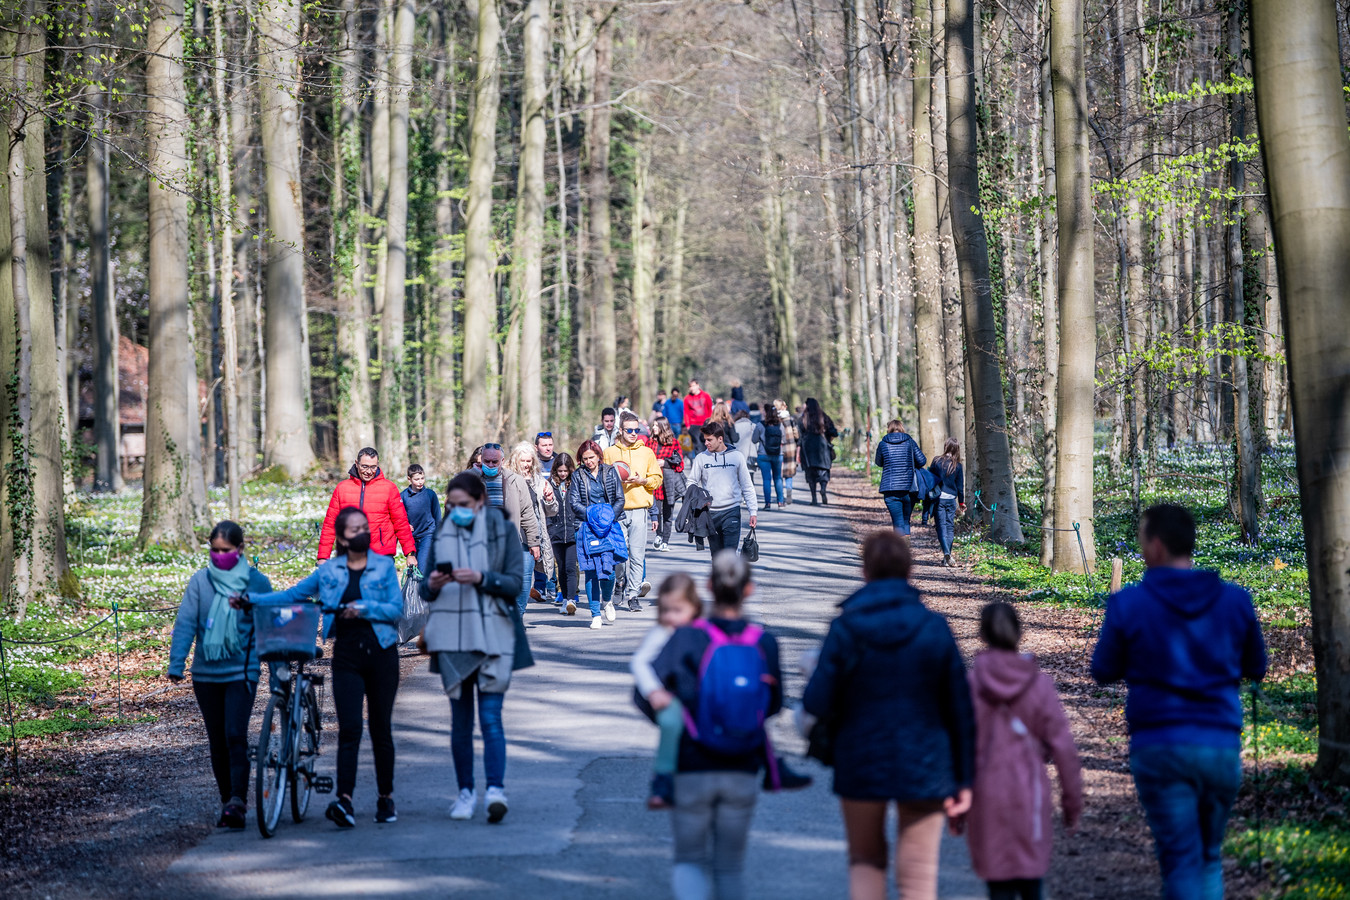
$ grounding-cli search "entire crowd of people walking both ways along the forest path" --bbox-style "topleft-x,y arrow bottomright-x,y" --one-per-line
169,367 -> 1266,900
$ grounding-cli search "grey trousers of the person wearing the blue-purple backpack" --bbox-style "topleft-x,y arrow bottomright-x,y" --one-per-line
671,772 -> 759,900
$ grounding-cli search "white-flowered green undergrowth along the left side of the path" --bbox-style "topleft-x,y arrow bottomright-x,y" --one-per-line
0,479 -> 332,745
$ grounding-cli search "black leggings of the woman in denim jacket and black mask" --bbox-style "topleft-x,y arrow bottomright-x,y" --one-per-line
332,622 -> 398,797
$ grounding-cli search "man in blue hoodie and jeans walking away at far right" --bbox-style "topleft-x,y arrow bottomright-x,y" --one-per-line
1092,503 -> 1266,900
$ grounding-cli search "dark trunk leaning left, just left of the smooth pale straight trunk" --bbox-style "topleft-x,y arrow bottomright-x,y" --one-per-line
946,0 -> 1020,544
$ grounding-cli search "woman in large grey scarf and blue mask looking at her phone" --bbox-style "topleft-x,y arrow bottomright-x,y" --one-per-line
423,472 -> 533,824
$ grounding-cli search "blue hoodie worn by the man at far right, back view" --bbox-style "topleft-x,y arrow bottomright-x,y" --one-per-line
1092,568 -> 1266,748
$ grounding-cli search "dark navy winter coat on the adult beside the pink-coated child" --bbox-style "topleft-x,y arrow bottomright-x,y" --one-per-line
802,579 -> 975,803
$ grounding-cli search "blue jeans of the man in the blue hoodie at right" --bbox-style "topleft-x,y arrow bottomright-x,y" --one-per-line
1130,743 -> 1242,900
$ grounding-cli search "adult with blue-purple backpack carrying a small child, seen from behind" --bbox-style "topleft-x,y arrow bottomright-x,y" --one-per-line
652,551 -> 783,900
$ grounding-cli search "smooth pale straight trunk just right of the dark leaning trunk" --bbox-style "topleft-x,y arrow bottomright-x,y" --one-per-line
1050,0 -> 1096,571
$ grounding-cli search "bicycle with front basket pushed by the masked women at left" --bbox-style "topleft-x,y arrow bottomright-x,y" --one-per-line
254,600 -> 333,838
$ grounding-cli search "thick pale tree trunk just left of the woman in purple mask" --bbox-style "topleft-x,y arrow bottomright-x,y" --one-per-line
138,0 -> 201,548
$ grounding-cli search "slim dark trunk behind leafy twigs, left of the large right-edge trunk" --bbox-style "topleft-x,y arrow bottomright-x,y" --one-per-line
1224,0 -> 1261,544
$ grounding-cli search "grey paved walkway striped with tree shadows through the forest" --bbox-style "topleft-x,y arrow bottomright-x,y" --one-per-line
170,496 -> 984,900
